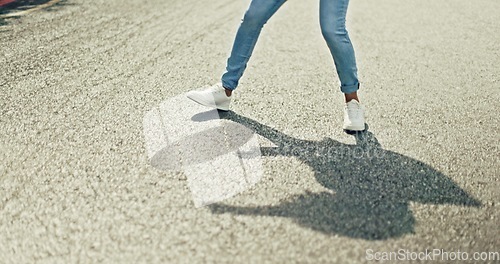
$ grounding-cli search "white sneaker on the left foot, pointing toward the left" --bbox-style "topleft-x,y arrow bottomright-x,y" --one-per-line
186,83 -> 232,111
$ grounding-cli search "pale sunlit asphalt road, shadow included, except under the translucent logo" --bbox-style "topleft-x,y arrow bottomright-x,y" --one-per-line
0,0 -> 500,263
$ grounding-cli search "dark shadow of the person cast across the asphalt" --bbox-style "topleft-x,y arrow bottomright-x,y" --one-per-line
192,112 -> 481,240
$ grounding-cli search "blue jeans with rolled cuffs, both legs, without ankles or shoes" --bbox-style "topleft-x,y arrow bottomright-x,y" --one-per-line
222,0 -> 359,93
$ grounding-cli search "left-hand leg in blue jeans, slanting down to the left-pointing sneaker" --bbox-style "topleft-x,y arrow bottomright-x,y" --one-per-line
222,0 -> 286,90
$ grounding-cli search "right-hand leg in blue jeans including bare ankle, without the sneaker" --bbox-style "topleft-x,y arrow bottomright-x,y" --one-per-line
320,0 -> 359,102
